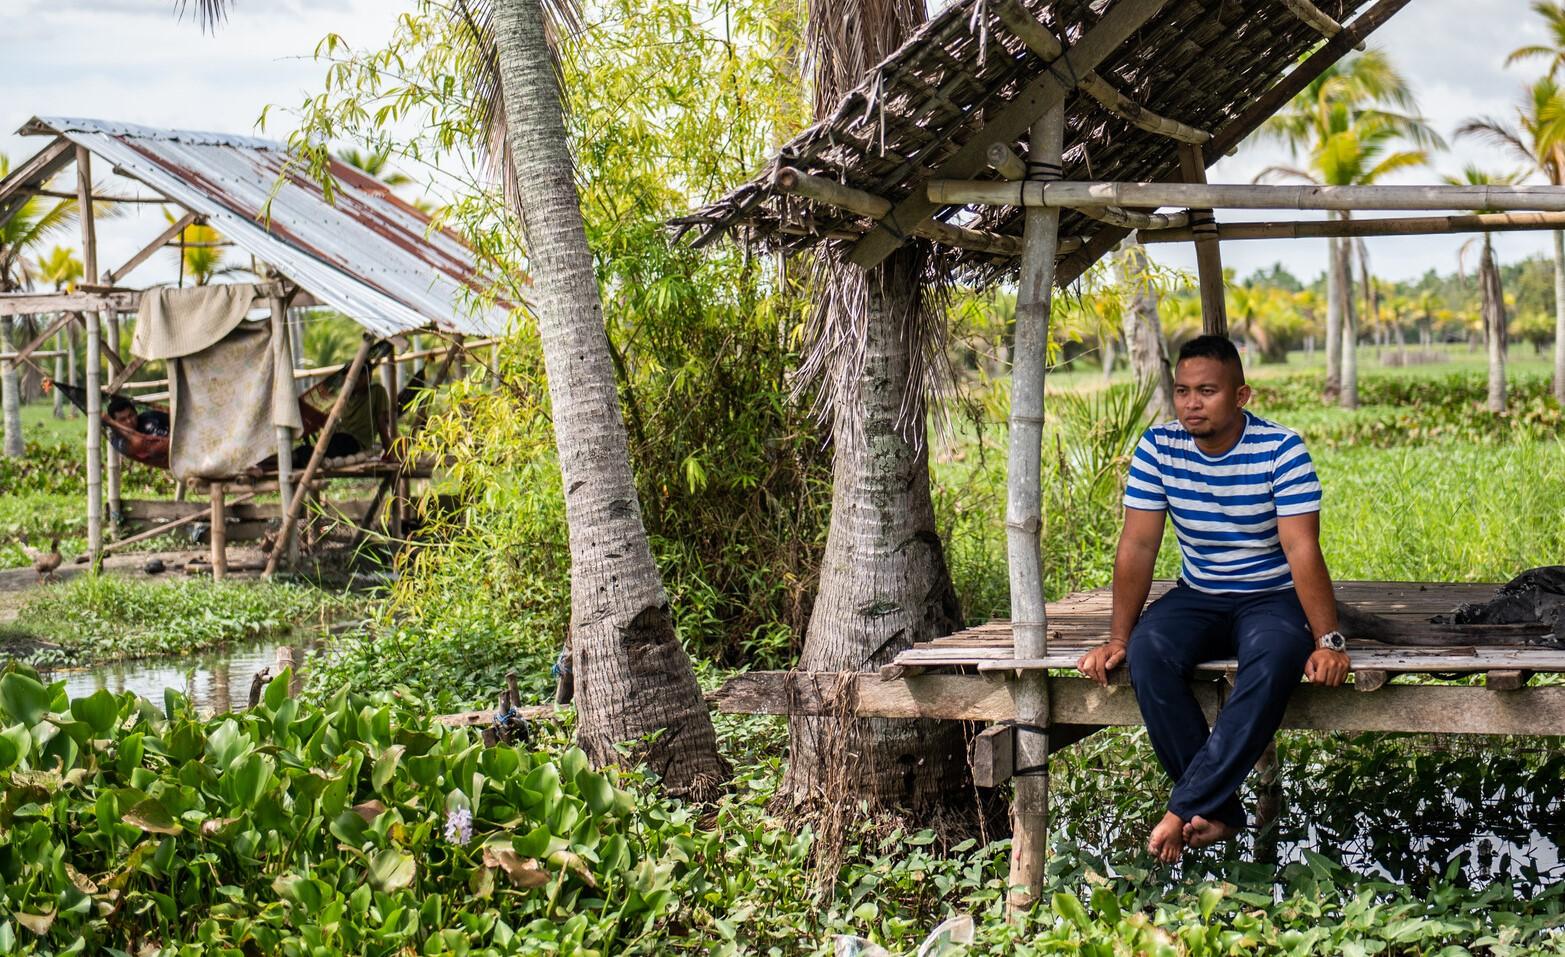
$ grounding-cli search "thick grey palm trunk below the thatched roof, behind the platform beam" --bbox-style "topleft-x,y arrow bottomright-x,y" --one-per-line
783,249 -> 970,808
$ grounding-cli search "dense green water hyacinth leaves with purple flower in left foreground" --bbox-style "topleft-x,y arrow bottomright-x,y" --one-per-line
0,669 -> 675,954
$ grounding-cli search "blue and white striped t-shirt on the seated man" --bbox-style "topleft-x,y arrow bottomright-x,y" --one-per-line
1125,413 -> 1321,593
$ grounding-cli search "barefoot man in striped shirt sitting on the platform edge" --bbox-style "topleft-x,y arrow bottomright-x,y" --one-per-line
1077,336 -> 1349,863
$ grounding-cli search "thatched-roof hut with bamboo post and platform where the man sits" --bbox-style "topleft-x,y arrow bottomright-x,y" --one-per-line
676,0 -> 1565,907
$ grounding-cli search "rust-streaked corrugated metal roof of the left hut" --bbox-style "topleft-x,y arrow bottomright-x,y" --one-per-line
22,116 -> 505,336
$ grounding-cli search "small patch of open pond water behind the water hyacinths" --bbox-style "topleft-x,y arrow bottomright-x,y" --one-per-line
49,635 -> 316,713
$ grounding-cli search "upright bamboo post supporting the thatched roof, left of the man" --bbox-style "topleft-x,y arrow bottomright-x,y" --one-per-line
1005,105 -> 1064,919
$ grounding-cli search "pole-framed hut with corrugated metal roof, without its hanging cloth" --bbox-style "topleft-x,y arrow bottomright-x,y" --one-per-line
0,117 -> 509,579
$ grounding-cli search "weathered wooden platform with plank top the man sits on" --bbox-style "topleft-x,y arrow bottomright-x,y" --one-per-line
712,582 -> 1565,763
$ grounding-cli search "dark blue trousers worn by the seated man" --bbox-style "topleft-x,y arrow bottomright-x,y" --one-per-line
1127,582 -> 1315,827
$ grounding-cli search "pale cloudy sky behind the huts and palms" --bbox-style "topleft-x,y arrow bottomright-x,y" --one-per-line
0,0 -> 1548,280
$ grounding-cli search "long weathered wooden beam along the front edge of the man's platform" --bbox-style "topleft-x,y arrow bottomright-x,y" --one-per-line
712,671 -> 1565,735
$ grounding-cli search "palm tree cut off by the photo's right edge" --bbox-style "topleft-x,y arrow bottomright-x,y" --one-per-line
1457,75 -> 1565,402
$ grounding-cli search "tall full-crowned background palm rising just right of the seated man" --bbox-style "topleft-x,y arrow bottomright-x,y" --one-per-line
1258,50 -> 1444,408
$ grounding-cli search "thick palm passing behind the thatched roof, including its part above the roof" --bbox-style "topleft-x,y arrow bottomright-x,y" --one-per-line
783,0 -> 966,807
